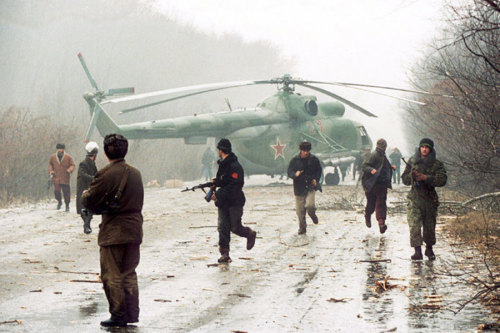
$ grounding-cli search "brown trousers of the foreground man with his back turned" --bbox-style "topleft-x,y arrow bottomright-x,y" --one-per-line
100,244 -> 140,323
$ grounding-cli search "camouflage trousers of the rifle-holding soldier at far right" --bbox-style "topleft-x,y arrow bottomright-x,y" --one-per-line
407,201 -> 437,247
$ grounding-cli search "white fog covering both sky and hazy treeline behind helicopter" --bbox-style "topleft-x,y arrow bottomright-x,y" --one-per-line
0,0 -> 446,189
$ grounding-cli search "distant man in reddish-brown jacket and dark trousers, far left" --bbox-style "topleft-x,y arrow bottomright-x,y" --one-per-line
49,143 -> 75,212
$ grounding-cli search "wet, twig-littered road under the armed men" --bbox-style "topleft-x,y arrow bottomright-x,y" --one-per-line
0,180 -> 490,332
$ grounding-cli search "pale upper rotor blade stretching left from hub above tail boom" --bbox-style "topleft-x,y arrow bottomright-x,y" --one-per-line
101,80 -> 270,104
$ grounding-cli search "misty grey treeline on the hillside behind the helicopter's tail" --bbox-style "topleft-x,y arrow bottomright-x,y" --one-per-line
0,0 -> 293,200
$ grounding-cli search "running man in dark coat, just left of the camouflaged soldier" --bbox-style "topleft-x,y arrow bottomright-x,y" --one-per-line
361,139 -> 395,234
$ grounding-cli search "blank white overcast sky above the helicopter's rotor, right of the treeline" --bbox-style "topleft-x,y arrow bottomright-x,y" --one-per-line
149,0 -> 442,149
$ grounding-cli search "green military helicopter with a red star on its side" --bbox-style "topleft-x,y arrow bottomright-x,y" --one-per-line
78,54 -> 430,185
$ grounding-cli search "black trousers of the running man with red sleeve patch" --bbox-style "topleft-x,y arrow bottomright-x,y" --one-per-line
217,206 -> 252,253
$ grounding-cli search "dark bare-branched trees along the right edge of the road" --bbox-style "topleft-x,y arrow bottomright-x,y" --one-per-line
406,0 -> 500,194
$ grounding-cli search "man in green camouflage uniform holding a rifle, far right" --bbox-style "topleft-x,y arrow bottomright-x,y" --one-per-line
401,138 -> 447,260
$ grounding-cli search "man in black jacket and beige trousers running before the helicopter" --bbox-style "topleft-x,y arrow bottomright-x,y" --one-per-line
288,141 -> 322,235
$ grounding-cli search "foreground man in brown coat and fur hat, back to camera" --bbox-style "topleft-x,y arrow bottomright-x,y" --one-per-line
82,134 -> 144,327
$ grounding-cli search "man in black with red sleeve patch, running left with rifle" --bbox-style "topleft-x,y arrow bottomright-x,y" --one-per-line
212,139 -> 257,263
